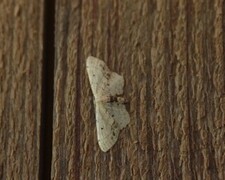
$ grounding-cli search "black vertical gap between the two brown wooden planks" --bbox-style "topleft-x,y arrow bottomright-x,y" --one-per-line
39,0 -> 55,179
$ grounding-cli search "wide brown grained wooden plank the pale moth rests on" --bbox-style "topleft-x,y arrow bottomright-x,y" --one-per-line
52,0 -> 225,179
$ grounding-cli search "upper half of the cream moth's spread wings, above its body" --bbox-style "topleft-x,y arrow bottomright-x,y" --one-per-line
86,56 -> 124,99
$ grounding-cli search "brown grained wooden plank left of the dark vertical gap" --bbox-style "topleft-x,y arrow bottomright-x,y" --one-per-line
0,0 -> 43,179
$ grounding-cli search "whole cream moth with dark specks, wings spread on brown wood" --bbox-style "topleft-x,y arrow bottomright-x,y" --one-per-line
87,56 -> 130,152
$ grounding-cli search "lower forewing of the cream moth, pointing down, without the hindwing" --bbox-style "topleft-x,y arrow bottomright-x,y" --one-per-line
96,102 -> 120,152
